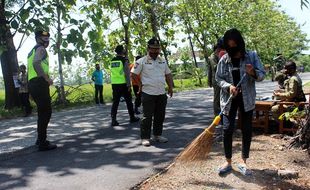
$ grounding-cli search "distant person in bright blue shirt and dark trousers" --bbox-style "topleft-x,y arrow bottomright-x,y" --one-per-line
91,64 -> 104,106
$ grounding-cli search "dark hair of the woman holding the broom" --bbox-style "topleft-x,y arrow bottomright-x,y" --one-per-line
224,28 -> 245,56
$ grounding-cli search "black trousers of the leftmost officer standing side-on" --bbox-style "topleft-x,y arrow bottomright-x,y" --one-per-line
28,77 -> 52,144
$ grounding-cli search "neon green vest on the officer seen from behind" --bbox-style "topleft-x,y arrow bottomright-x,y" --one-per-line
110,60 -> 126,84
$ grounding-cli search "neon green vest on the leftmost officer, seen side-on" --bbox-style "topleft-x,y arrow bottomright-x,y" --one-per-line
27,46 -> 49,80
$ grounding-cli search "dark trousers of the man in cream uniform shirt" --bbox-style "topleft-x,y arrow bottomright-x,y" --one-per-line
140,92 -> 167,139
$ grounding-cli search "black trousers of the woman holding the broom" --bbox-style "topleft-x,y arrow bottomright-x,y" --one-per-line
223,94 -> 253,159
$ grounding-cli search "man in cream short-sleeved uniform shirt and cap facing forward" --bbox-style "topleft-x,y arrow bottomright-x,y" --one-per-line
131,38 -> 173,146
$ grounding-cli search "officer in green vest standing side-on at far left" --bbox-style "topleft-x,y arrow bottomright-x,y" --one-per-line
28,30 -> 57,151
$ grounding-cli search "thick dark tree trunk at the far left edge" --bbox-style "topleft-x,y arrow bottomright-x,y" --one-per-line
0,1 -> 20,109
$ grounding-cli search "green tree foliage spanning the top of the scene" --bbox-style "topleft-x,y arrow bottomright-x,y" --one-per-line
0,0 -> 309,109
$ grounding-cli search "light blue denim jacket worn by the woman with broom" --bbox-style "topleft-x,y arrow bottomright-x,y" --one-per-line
215,51 -> 266,115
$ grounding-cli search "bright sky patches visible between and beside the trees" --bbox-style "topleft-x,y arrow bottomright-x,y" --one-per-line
0,0 -> 310,76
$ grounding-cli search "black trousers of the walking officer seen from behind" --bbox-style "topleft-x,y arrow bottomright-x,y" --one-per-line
111,84 -> 134,120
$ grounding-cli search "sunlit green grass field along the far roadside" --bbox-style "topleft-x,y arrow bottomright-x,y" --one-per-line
0,78 -> 207,119
